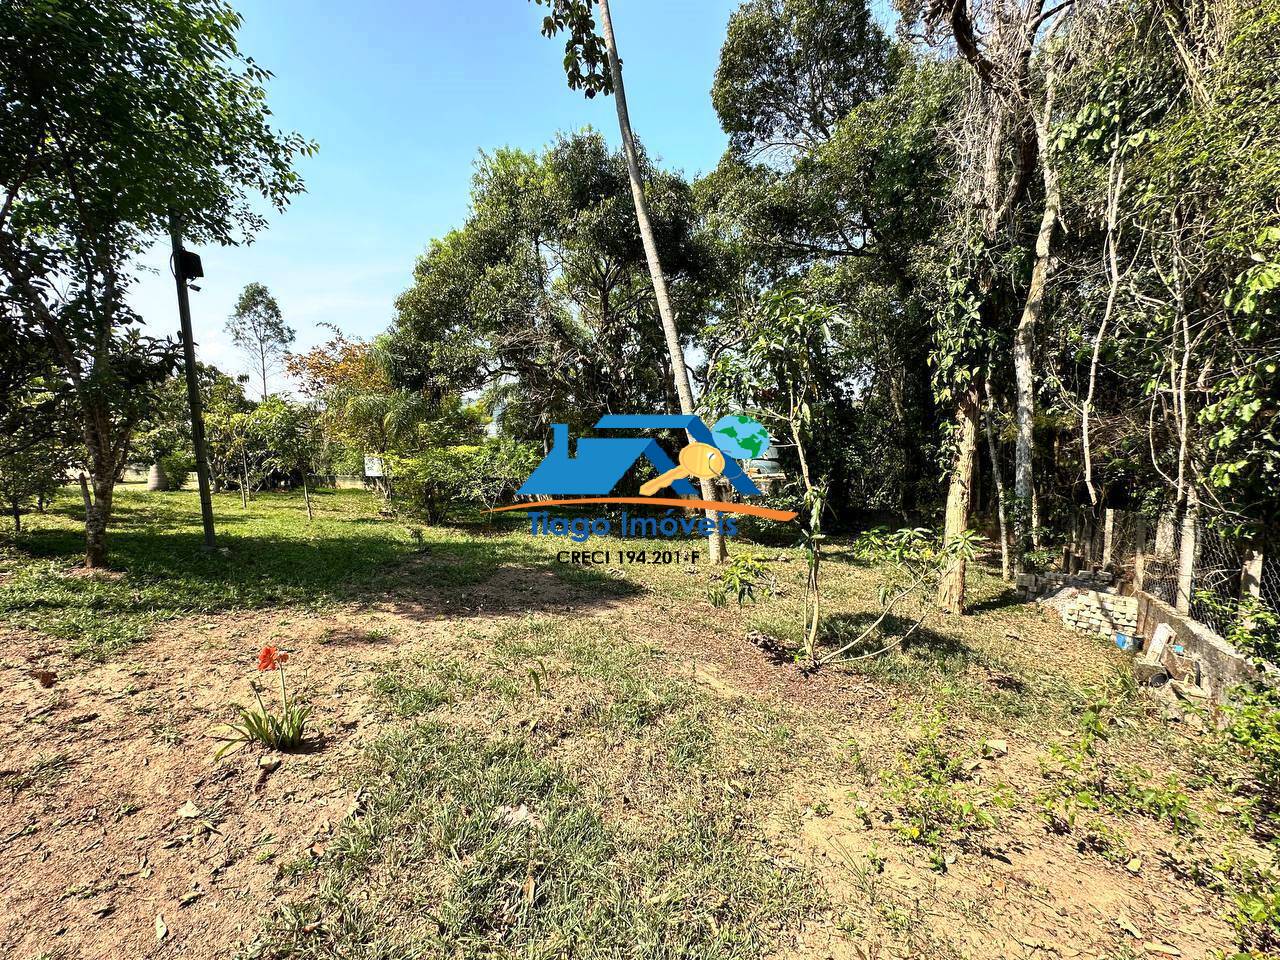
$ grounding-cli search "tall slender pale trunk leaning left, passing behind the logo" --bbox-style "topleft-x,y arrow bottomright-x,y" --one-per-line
599,0 -> 723,563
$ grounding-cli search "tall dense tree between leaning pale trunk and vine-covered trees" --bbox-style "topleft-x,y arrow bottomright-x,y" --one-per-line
698,0 -> 963,518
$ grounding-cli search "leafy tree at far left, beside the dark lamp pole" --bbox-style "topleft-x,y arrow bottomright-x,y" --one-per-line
0,0 -> 312,567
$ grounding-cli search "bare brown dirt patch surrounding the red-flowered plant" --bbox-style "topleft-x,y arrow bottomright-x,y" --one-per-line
0,611 -> 412,960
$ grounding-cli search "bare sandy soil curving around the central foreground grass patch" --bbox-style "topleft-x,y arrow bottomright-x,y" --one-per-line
0,504 -> 1259,960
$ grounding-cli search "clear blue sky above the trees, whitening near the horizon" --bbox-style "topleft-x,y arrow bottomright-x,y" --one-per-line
124,0 -> 737,388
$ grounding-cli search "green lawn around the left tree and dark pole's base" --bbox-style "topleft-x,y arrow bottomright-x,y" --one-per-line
0,485 -> 545,658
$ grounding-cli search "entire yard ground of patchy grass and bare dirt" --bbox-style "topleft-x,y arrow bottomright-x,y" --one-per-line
0,489 -> 1260,960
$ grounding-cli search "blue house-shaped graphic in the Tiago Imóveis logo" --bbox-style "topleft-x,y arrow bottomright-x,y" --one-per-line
517,413 -> 760,497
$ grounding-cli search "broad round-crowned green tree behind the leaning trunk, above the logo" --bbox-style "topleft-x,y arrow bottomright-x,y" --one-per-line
385,132 -> 712,438
